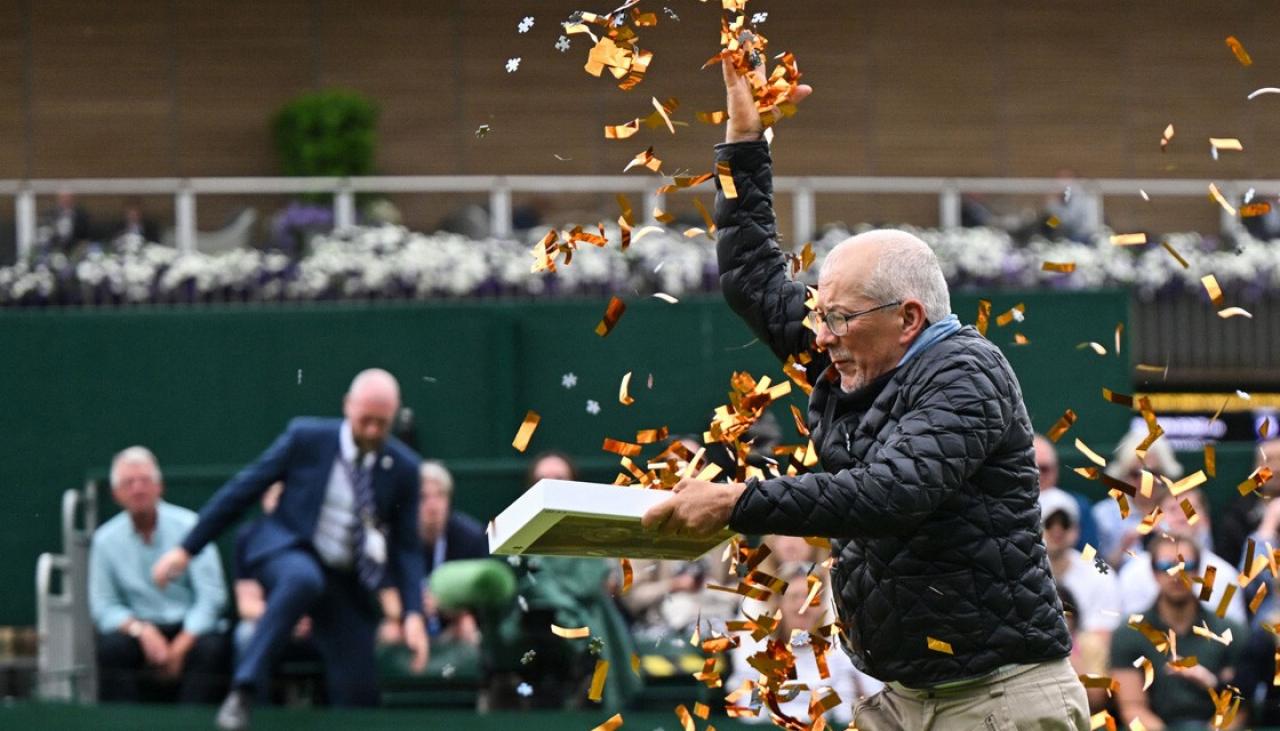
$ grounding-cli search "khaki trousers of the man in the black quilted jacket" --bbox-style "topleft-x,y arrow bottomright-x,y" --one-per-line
854,658 -> 1089,731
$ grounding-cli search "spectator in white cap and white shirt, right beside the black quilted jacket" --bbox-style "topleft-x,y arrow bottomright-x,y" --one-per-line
1039,488 -> 1120,712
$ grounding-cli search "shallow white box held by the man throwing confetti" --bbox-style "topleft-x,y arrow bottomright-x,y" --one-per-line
489,480 -> 736,561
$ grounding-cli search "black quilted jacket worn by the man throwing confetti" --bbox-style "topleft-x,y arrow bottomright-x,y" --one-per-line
716,142 -> 1071,686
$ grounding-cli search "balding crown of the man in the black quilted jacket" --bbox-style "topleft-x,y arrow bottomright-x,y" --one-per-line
818,229 -> 951,323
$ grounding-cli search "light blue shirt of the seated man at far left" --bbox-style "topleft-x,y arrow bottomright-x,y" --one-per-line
88,501 -> 227,635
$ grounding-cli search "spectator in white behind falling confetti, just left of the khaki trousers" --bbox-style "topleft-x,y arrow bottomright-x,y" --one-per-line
726,562 -> 884,725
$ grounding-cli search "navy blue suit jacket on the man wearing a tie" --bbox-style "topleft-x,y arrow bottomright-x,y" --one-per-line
182,417 -> 422,613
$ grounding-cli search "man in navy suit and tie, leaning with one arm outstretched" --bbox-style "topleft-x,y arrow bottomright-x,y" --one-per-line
152,369 -> 428,730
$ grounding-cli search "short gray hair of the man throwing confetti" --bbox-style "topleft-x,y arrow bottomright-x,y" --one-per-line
820,229 -> 951,324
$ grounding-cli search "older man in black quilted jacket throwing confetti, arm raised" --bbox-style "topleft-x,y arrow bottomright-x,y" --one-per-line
645,57 -> 1089,731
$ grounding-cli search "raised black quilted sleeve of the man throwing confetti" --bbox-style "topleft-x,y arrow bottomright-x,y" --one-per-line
716,141 -> 817,373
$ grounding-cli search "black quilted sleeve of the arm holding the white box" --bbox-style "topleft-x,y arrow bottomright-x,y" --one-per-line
730,358 -> 1014,539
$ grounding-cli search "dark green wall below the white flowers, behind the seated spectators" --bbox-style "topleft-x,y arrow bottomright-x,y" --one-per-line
0,292 -> 1129,625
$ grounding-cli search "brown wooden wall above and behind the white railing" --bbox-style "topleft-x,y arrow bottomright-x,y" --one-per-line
10,0 -> 1280,230
